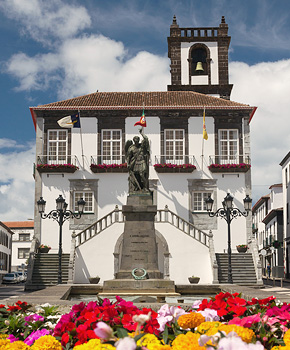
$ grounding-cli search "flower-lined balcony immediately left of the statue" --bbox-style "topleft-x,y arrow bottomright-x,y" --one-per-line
90,155 -> 128,173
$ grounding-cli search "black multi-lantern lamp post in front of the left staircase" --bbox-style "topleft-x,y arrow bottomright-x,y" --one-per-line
37,194 -> 86,284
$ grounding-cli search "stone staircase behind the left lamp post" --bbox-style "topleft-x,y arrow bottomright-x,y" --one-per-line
26,253 -> 69,290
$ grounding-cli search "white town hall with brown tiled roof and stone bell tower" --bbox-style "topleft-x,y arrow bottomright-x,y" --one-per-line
30,18 -> 256,284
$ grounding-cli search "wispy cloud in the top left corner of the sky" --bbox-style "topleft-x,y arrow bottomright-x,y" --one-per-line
0,0 -> 91,45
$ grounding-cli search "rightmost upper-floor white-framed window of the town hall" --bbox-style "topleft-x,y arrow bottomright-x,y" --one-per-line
219,129 -> 239,164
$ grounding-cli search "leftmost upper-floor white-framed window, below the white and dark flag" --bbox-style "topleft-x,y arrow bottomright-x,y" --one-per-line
47,130 -> 68,164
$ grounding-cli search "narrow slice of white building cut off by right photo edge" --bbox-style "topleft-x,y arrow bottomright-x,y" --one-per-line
280,152 -> 290,278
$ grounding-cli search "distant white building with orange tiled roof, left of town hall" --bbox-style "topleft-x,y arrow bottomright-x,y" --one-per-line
4,221 -> 34,271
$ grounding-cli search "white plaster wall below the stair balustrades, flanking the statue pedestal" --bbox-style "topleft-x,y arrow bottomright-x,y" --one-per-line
74,223 -> 213,284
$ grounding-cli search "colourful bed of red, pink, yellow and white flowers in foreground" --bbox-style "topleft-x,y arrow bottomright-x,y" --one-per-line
0,293 -> 290,350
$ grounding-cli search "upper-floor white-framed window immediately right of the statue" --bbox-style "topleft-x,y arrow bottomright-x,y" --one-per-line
164,129 -> 184,164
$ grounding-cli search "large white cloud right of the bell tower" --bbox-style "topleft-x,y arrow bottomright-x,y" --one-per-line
230,60 -> 290,200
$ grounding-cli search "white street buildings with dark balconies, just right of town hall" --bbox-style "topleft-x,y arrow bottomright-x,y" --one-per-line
252,184 -> 284,277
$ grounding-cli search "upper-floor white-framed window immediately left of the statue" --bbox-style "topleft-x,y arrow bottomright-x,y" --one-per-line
102,129 -> 122,164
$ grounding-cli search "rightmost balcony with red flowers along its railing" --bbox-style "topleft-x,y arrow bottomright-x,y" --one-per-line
208,155 -> 251,173
